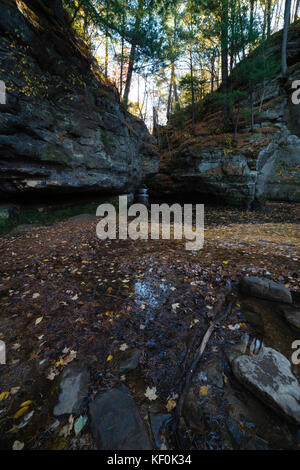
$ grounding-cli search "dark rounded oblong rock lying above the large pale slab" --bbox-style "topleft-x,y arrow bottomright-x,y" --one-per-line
240,276 -> 293,304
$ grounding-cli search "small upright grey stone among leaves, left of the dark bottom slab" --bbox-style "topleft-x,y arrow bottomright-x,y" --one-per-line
53,367 -> 90,416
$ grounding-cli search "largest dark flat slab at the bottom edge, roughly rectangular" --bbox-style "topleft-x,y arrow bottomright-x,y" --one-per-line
89,386 -> 152,450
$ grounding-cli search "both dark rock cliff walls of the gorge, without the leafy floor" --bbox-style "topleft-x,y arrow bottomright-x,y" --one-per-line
0,0 -> 300,218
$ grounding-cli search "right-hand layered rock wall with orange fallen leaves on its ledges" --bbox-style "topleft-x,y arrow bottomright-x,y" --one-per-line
150,23 -> 300,207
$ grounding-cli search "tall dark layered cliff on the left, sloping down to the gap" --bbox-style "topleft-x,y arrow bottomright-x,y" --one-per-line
0,0 -> 159,199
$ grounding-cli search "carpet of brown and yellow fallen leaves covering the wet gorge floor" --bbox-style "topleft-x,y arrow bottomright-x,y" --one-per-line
0,204 -> 300,449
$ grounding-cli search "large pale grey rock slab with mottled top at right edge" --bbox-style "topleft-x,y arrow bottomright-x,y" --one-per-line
232,347 -> 300,424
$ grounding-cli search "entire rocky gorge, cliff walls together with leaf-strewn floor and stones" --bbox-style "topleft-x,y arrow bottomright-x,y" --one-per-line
0,0 -> 300,452
